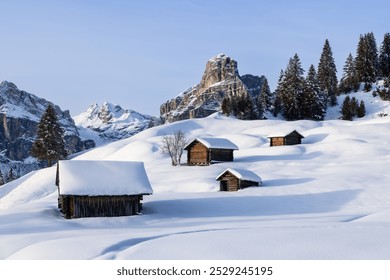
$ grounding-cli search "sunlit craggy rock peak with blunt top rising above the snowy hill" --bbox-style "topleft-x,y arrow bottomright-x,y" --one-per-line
160,54 -> 261,123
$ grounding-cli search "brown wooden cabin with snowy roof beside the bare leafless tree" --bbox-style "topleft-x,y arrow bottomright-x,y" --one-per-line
184,138 -> 238,165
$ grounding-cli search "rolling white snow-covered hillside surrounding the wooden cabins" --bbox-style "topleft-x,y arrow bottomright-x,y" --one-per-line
0,93 -> 390,260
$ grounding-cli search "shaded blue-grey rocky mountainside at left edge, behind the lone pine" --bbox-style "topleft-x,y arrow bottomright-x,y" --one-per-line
0,81 -> 94,179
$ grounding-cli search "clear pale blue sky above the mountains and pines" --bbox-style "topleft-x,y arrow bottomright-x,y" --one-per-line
0,0 -> 390,116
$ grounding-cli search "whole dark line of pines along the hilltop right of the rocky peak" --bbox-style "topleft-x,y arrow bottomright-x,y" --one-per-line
221,32 -> 390,121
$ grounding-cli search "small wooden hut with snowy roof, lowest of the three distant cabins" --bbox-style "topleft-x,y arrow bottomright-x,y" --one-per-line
216,168 -> 262,192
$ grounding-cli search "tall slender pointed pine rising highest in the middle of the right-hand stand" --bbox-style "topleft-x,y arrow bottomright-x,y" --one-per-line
318,39 -> 337,106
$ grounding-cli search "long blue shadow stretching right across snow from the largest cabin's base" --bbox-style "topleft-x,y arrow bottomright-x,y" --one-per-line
143,190 -> 361,219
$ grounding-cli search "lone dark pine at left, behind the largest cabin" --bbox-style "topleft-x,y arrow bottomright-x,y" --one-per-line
30,105 -> 68,166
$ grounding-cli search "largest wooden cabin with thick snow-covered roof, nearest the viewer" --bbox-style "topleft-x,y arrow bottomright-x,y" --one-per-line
56,160 -> 153,219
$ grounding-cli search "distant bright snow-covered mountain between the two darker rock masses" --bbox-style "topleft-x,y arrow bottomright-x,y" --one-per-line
73,102 -> 160,144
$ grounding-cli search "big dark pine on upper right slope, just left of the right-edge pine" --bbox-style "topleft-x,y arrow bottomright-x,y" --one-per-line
355,32 -> 379,91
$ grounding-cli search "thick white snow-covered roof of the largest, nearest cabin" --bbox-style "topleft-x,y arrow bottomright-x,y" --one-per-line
58,160 -> 153,195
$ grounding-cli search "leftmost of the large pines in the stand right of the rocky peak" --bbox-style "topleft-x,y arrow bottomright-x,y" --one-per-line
280,54 -> 305,120
